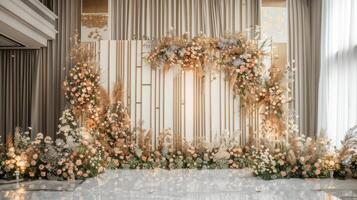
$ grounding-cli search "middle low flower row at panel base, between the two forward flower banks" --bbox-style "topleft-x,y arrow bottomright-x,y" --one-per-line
91,130 -> 247,169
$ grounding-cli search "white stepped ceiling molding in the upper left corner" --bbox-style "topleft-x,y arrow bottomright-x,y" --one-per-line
0,0 -> 57,49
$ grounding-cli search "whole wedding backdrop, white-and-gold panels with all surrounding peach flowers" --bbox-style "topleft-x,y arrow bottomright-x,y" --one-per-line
0,30 -> 356,183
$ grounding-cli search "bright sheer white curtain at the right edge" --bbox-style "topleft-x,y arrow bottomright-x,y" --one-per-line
318,0 -> 357,146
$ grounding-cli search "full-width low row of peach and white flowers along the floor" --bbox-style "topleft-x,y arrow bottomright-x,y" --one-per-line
0,126 -> 357,180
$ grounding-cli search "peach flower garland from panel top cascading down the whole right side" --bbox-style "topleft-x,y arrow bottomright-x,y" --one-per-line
148,33 -> 291,139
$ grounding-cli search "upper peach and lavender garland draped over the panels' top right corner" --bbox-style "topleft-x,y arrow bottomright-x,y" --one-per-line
148,34 -> 264,99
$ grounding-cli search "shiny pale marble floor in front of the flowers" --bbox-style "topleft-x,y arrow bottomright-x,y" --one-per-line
0,169 -> 357,200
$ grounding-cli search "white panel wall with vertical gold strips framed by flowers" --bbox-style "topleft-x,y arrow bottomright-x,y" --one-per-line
97,40 -> 258,148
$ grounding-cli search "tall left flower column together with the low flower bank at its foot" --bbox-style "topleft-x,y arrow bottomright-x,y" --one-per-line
0,34 -> 107,180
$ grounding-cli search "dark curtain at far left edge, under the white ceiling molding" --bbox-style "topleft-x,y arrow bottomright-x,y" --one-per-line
0,50 -> 38,142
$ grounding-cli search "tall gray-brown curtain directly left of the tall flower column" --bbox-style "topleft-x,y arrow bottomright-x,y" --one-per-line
31,0 -> 81,137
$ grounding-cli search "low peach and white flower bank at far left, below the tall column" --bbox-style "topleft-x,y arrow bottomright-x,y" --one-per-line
0,127 -> 104,180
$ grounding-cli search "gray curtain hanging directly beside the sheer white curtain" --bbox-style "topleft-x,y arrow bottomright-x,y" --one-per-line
288,0 -> 321,137
